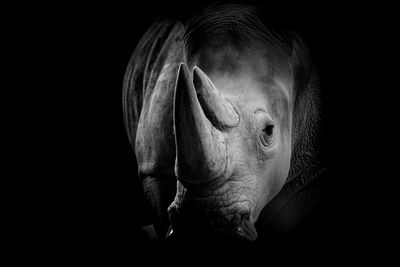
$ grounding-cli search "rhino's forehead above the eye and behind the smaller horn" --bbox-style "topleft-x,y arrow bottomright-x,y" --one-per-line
195,46 -> 293,117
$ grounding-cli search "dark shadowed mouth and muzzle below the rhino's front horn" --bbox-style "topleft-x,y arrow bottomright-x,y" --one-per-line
168,182 -> 257,241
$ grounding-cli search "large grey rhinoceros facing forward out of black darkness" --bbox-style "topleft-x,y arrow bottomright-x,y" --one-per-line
123,5 -> 324,251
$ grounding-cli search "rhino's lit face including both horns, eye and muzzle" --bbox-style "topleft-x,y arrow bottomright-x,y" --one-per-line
168,59 -> 292,241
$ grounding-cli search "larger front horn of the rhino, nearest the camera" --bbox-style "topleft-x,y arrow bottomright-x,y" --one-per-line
173,63 -> 229,185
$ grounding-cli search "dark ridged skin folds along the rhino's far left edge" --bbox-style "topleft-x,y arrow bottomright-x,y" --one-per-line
122,19 -> 184,148
